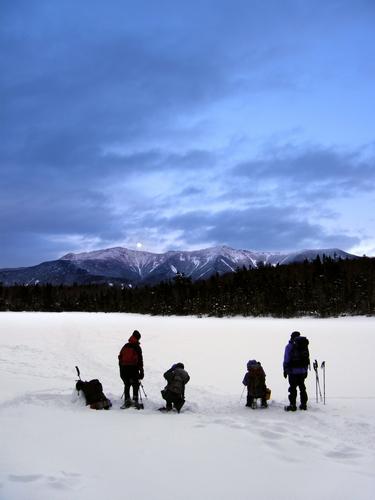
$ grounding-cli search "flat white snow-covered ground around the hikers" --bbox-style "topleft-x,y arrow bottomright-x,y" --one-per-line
0,313 -> 375,500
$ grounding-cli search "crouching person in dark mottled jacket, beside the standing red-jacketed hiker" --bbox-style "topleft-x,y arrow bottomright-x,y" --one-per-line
159,363 -> 190,413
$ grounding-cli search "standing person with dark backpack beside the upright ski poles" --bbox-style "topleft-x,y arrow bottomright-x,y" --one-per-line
283,332 -> 310,411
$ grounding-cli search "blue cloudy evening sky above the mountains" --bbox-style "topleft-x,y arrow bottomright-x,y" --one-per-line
0,0 -> 375,268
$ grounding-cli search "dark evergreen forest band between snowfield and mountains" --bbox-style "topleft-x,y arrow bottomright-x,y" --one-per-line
0,257 -> 375,317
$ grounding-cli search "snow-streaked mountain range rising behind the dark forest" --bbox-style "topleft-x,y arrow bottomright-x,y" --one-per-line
0,246 -> 357,286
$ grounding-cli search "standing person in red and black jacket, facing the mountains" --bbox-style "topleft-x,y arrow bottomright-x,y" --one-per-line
118,330 -> 144,408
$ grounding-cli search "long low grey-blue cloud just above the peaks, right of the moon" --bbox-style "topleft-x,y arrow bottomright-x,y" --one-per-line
145,207 -> 359,251
